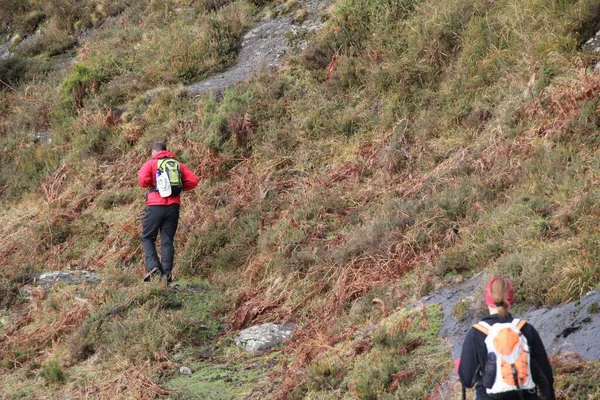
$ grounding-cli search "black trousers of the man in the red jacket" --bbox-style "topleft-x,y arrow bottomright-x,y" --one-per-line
142,204 -> 179,275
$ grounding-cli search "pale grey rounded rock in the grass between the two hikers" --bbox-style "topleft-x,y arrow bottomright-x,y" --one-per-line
235,322 -> 296,353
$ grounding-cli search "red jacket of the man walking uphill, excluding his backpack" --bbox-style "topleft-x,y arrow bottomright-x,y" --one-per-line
138,150 -> 198,206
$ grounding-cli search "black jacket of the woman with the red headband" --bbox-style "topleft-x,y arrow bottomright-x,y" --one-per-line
458,314 -> 556,400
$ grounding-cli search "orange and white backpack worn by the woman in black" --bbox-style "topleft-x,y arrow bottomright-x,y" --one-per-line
473,319 -> 536,395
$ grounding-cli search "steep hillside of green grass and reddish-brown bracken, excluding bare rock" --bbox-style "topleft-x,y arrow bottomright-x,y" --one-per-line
0,0 -> 600,400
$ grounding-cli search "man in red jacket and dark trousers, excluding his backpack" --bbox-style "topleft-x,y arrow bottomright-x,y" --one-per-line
138,142 -> 198,284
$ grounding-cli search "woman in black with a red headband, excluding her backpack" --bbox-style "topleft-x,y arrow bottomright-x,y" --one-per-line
455,278 -> 556,400
